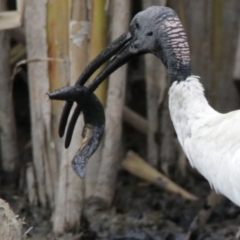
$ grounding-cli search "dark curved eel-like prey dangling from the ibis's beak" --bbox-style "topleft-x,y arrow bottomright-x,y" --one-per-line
48,86 -> 105,178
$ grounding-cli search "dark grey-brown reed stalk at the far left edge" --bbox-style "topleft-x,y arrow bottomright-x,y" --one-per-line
0,1 -> 19,172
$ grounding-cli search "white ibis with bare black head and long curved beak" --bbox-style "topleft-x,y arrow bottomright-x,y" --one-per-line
49,6 -> 240,205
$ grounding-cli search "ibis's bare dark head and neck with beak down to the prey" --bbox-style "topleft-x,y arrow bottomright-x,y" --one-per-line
83,6 -> 191,93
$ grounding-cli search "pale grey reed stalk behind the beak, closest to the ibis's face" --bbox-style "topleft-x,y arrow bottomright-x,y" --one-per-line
90,0 -> 130,207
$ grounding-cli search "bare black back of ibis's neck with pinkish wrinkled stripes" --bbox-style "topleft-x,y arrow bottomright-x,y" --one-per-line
158,17 -> 191,84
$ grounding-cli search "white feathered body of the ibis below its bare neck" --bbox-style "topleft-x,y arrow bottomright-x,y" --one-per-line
169,76 -> 240,205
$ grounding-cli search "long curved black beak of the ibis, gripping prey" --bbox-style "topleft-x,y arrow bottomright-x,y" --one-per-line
59,32 -> 144,148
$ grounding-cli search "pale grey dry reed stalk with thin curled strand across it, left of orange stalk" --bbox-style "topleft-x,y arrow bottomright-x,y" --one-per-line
24,0 -> 61,207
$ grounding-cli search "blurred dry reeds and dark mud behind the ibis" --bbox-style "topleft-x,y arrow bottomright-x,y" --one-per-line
0,0 -> 240,240
